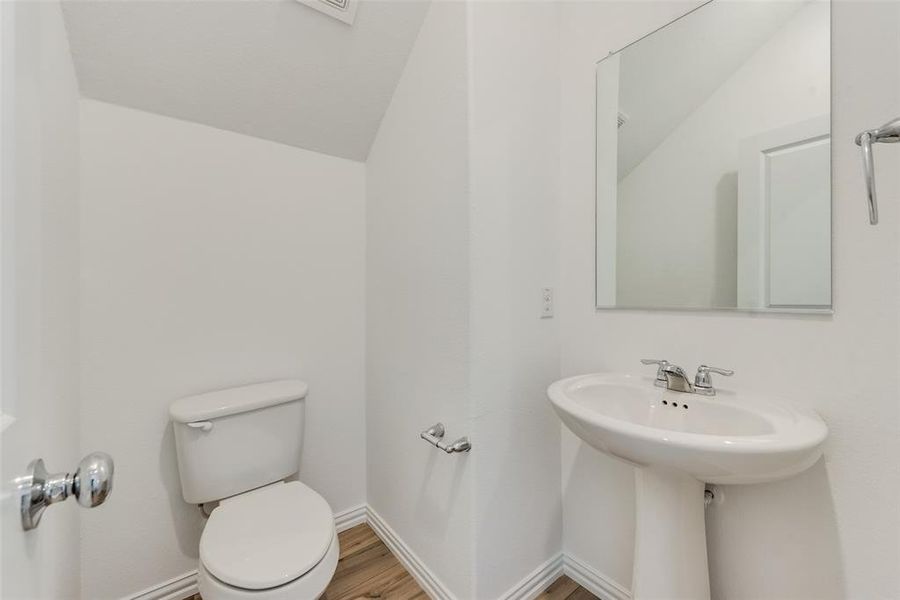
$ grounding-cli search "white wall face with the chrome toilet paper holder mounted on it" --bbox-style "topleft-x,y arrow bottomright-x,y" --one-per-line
366,2 -> 478,598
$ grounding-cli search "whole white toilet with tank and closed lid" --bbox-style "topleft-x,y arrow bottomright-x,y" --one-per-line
169,380 -> 340,600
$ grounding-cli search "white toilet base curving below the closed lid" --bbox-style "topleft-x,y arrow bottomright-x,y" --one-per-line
197,532 -> 340,600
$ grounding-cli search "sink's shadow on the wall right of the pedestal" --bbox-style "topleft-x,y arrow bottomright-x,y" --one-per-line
706,458 -> 848,600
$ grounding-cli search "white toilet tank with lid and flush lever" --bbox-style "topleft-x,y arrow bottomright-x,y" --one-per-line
169,380 -> 307,504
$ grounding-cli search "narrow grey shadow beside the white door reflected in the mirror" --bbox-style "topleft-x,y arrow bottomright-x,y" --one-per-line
710,171 -> 738,308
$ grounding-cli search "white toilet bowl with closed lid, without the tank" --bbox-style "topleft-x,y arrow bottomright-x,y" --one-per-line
198,481 -> 339,600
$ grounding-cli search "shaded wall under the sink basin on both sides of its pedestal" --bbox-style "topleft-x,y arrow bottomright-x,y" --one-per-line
563,440 -> 852,600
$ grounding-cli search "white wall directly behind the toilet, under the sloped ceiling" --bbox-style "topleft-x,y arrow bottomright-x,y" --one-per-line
81,100 -> 365,599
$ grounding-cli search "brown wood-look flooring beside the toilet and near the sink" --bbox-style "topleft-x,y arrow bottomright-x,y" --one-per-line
187,525 -> 599,600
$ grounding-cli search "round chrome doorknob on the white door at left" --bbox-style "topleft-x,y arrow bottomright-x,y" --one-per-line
18,452 -> 114,531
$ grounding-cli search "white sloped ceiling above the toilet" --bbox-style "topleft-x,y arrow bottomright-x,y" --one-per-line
63,0 -> 428,160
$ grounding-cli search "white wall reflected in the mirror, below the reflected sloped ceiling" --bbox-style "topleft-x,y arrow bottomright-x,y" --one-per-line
616,2 -> 830,307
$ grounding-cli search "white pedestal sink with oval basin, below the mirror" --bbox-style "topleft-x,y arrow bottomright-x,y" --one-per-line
547,374 -> 828,600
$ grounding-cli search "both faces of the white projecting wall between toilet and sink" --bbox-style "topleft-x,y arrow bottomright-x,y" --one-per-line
368,2 -> 561,599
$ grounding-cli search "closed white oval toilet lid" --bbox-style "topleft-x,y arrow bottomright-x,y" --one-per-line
200,481 -> 334,590
